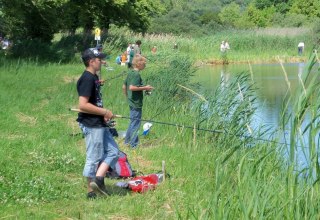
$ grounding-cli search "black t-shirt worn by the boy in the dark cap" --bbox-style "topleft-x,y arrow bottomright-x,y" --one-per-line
77,71 -> 106,128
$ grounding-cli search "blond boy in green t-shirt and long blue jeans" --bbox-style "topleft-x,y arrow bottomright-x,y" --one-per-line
122,54 -> 153,148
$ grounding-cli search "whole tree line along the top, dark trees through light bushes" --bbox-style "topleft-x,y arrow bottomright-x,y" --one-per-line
0,0 -> 320,42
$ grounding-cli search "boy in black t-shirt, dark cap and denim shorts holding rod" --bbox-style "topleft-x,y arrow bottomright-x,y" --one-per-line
77,48 -> 119,198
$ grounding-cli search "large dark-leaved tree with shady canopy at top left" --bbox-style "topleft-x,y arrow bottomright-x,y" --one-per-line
0,0 -> 164,42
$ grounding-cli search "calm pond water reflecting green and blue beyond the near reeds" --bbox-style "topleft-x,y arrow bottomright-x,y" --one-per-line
195,63 -> 318,169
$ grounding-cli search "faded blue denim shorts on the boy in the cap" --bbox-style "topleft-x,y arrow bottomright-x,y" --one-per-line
79,123 -> 119,178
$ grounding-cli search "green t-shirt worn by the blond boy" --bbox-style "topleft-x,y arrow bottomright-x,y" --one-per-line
124,70 -> 143,108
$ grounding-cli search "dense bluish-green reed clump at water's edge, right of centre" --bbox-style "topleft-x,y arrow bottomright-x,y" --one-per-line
198,73 -> 257,148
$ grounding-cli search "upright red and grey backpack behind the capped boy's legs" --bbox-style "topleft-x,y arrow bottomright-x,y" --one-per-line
106,151 -> 136,179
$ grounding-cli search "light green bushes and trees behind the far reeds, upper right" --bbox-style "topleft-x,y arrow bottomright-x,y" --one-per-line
148,0 -> 318,35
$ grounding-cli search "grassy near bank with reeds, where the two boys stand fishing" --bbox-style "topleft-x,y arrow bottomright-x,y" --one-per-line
0,51 -> 320,219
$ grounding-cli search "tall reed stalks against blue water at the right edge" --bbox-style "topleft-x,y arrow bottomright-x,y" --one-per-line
281,51 -> 320,180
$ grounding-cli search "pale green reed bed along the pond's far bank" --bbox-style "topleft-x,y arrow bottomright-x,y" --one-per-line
110,29 -> 314,64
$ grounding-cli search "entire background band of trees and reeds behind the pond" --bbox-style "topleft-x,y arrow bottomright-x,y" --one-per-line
0,0 -> 320,64
